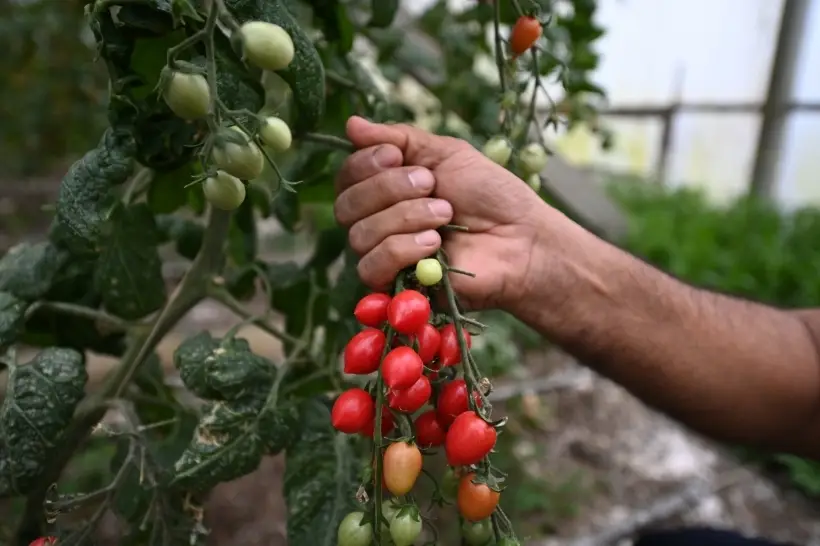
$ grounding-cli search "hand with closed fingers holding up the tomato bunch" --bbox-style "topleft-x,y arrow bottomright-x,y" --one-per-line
335,117 -> 565,309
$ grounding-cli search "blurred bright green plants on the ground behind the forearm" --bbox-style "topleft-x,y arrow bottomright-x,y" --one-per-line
611,179 -> 820,496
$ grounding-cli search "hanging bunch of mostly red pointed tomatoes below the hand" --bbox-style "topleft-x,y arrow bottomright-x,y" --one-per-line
332,276 -> 500,545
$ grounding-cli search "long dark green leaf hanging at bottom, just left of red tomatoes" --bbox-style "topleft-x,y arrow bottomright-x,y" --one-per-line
284,399 -> 359,546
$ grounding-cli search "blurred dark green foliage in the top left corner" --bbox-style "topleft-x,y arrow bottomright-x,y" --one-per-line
0,0 -> 108,177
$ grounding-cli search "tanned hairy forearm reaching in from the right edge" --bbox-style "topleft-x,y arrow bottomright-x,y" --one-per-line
513,215 -> 820,458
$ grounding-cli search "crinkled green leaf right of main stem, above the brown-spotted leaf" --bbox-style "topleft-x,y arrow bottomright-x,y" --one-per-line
174,332 -> 276,400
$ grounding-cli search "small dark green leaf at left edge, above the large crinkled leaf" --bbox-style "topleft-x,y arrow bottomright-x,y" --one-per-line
0,241 -> 68,301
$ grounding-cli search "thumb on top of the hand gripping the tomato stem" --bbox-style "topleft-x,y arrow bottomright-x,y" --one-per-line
347,116 -> 459,169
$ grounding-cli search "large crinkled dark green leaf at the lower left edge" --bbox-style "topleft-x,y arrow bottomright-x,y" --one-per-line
0,347 -> 88,494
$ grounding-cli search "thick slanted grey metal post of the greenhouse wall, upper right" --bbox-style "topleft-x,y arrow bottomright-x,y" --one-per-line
749,0 -> 811,199
